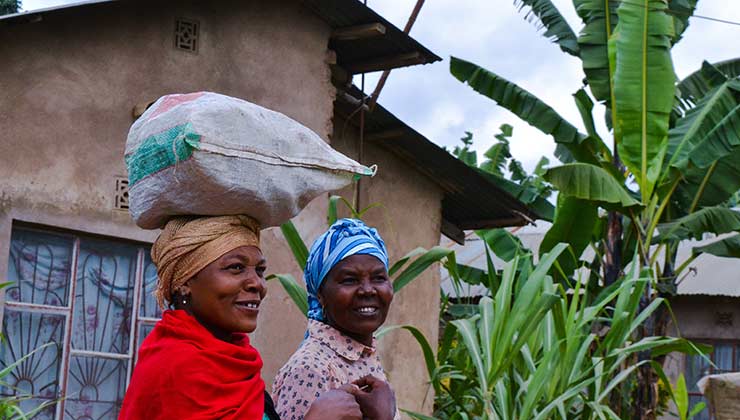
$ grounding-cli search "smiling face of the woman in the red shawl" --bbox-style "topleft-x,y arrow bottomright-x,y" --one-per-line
180,246 -> 267,340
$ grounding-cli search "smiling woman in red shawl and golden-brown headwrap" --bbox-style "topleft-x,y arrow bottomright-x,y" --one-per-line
119,216 -> 366,420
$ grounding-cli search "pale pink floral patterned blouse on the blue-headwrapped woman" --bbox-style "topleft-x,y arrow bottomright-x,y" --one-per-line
272,319 -> 401,420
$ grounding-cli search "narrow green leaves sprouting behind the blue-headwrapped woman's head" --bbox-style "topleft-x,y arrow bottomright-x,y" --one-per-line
267,196 -> 452,315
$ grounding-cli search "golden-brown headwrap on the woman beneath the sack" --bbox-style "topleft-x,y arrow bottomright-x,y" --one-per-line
152,216 -> 260,309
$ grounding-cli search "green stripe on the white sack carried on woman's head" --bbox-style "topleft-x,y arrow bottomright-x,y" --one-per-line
126,123 -> 200,186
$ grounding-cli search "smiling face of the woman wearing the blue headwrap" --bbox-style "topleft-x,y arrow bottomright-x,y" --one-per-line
318,255 -> 393,345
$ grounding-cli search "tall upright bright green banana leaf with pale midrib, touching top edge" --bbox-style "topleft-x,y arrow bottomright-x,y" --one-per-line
614,0 -> 675,202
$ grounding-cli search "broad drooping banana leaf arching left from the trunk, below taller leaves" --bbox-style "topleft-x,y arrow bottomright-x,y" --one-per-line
545,163 -> 641,213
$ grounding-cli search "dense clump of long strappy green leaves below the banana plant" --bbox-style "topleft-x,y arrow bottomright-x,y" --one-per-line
402,244 -> 709,420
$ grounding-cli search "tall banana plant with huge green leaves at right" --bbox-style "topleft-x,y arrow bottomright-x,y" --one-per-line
450,0 -> 740,418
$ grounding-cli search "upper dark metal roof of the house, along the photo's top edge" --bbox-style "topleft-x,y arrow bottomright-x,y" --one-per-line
0,0 -> 441,73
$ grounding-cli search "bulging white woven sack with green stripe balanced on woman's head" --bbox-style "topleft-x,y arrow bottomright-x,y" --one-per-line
125,92 -> 373,229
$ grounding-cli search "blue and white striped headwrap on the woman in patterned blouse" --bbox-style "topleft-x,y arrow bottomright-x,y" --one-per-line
303,219 -> 388,321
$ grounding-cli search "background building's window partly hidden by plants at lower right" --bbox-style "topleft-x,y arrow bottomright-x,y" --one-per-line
684,340 -> 740,420
